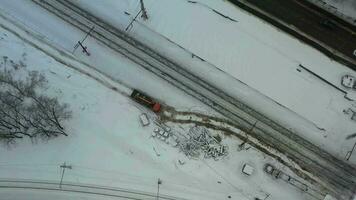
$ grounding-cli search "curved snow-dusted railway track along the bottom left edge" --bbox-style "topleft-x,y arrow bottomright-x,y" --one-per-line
0,179 -> 187,200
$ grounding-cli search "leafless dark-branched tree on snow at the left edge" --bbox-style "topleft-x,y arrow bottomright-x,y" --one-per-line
0,66 -> 71,143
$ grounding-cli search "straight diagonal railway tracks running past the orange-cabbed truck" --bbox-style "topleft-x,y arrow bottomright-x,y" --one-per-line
32,0 -> 356,199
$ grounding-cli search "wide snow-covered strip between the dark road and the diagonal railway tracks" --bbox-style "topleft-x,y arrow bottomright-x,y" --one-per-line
69,0 -> 356,161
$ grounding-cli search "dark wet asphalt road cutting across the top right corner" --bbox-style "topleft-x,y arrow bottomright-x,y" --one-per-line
229,0 -> 356,71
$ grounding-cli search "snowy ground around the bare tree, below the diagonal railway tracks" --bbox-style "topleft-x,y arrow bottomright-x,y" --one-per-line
0,3 -> 311,199
